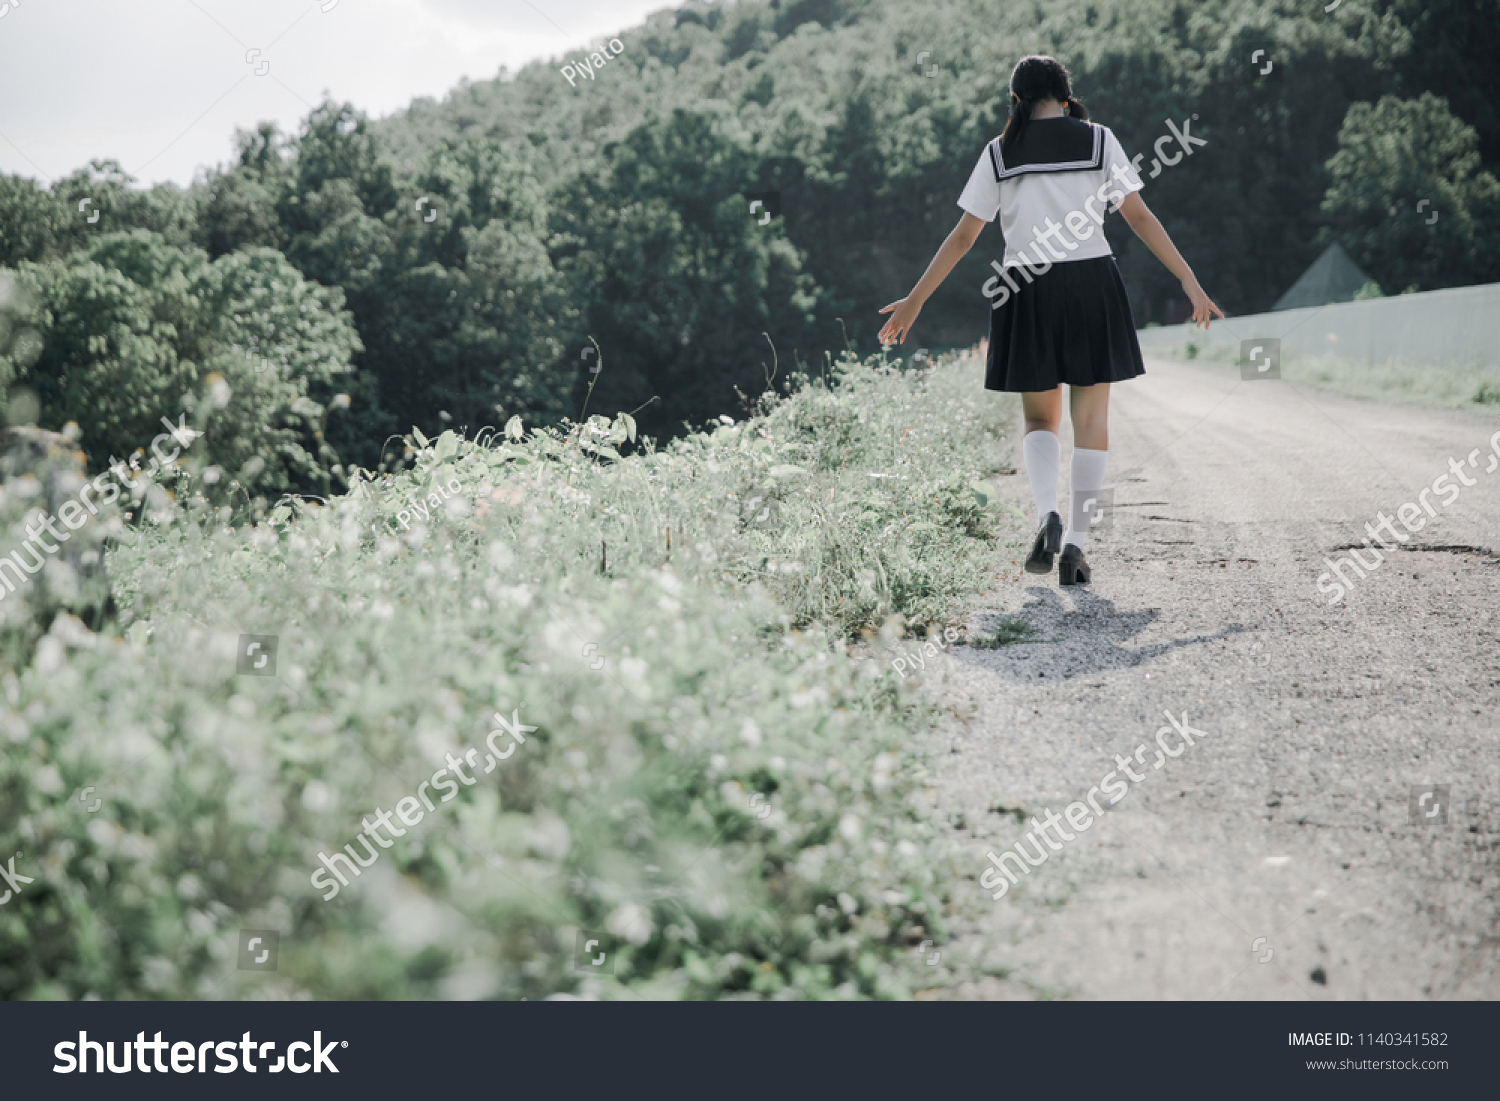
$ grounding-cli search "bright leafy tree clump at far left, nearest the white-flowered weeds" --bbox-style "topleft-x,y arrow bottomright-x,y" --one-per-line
0,230 -> 359,492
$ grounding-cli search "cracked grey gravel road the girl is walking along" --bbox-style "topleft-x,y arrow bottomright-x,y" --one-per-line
923,360 -> 1500,999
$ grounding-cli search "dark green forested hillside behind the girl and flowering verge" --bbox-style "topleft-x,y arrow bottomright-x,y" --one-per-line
0,0 -> 1500,492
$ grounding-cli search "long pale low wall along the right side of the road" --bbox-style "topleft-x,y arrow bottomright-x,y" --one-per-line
1137,284 -> 1500,368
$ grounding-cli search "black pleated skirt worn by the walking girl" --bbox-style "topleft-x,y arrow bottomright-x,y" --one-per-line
984,257 -> 1146,393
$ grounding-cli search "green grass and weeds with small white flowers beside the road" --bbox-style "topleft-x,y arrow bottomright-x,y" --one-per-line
0,351 -> 1014,999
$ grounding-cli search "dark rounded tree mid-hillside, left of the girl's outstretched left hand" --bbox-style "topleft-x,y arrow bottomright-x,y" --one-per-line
558,110 -> 818,434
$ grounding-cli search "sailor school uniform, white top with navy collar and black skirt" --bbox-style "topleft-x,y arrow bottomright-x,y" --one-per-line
959,116 -> 1146,393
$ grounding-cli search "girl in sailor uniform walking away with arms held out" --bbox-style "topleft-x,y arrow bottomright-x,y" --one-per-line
881,57 -> 1224,585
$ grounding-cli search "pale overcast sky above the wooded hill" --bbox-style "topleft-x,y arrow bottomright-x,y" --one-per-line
0,0 -> 672,186
